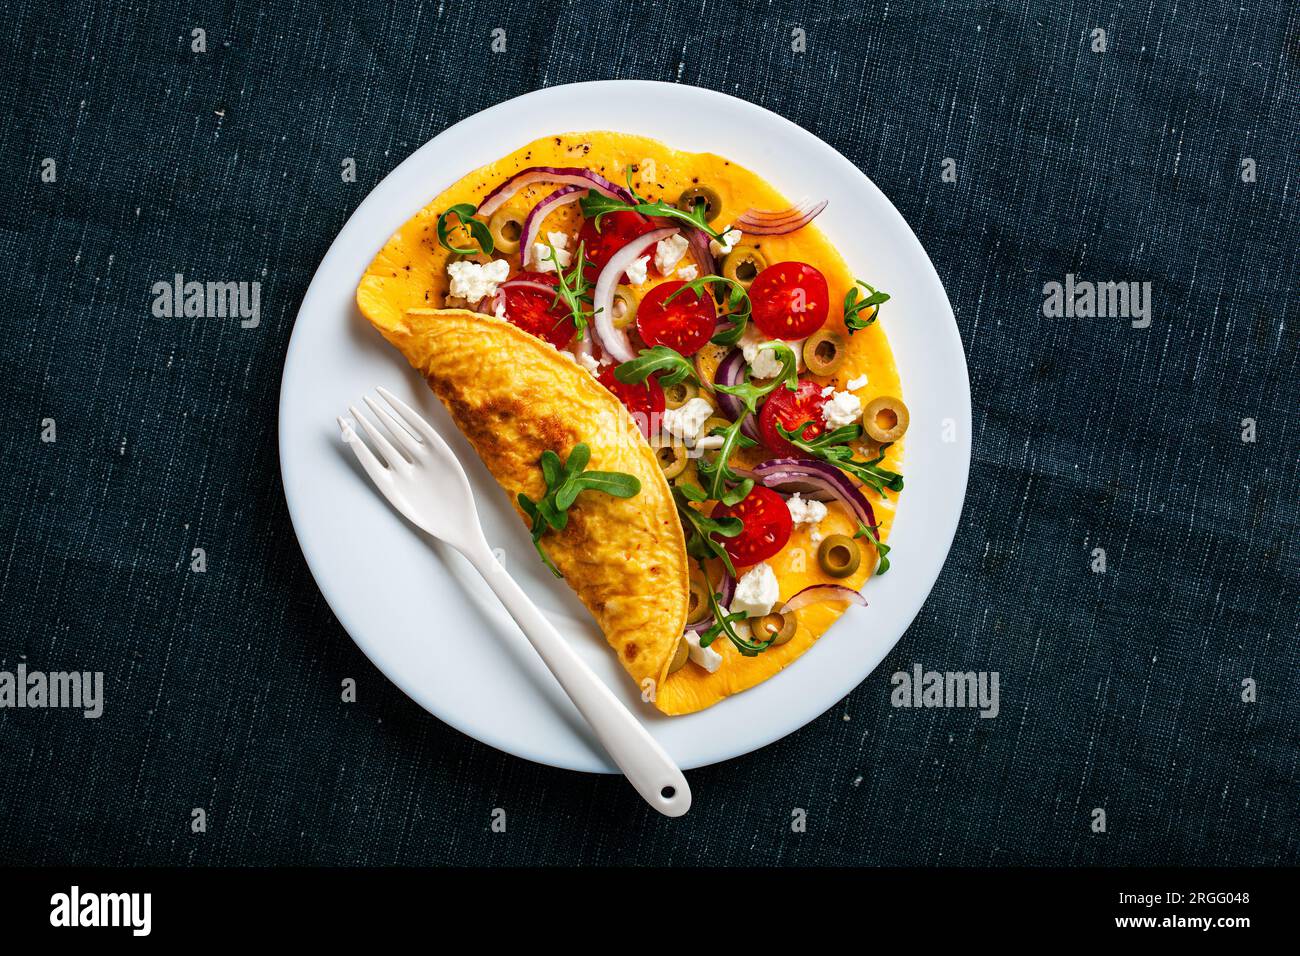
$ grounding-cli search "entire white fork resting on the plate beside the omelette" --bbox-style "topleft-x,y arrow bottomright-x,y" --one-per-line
338,386 -> 690,817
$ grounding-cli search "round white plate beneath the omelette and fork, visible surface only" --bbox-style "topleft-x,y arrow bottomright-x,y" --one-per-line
280,81 -> 971,773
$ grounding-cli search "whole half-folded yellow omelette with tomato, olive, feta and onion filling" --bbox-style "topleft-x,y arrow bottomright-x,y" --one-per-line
358,133 -> 907,714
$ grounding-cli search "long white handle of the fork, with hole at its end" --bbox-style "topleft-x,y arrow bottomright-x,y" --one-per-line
465,549 -> 690,817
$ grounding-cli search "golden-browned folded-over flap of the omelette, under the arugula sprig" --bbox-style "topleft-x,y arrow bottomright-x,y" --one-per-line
372,308 -> 688,696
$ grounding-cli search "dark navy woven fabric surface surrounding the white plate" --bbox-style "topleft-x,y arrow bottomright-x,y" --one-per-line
0,0 -> 1300,864
